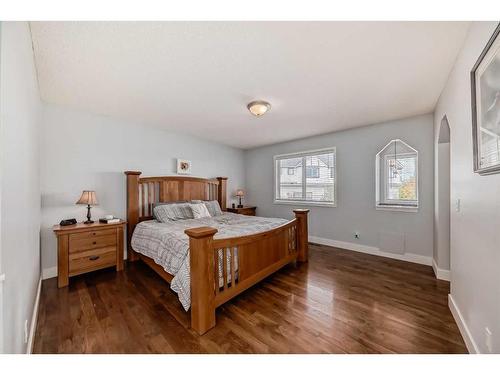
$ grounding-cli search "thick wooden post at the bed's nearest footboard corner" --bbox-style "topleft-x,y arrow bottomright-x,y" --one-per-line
184,227 -> 217,335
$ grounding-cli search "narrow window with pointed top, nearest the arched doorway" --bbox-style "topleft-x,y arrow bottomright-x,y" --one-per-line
376,139 -> 418,211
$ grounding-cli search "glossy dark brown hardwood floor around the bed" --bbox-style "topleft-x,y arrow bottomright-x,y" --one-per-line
34,245 -> 467,353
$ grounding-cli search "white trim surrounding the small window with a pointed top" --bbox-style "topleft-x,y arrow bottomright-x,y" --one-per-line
375,139 -> 420,212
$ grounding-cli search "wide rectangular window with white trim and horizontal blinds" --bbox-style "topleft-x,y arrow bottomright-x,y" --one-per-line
274,148 -> 336,206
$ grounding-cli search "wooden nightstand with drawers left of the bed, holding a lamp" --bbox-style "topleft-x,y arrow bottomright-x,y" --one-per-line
53,221 -> 126,288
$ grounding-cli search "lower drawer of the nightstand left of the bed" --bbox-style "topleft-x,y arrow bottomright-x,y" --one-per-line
69,247 -> 116,276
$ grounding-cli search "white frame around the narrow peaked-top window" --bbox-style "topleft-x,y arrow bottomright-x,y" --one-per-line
375,139 -> 420,212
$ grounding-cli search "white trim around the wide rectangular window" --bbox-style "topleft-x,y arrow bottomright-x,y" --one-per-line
273,147 -> 338,207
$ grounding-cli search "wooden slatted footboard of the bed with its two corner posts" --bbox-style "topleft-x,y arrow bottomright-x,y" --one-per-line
185,209 -> 309,335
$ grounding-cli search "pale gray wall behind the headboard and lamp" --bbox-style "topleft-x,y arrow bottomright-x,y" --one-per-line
41,105 -> 244,277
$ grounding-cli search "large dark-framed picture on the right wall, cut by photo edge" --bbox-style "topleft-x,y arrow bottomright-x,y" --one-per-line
471,24 -> 500,175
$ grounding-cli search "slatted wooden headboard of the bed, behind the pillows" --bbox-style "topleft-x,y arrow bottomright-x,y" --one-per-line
125,171 -> 227,260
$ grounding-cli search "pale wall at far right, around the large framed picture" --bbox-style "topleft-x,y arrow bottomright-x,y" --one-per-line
434,22 -> 500,353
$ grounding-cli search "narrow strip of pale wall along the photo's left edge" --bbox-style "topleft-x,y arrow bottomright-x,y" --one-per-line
0,22 -> 41,353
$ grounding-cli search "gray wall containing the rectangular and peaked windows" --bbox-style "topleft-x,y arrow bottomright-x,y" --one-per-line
245,114 -> 434,262
